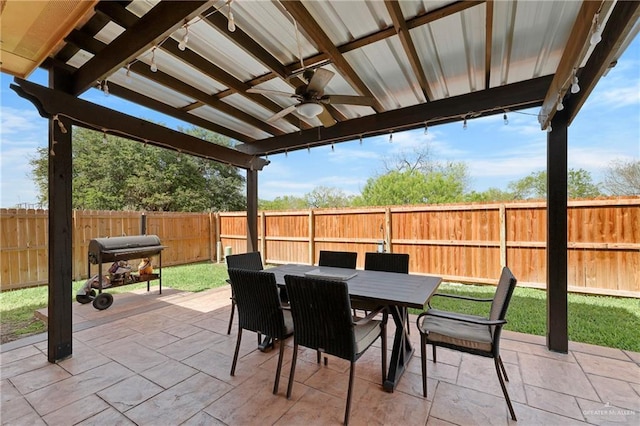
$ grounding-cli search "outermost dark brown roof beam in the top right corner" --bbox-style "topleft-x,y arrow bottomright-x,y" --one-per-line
564,1 -> 640,125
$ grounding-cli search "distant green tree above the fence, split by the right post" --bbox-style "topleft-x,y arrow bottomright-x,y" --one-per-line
508,169 -> 602,200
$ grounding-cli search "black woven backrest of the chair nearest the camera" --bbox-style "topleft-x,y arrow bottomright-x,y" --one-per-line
284,275 -> 356,361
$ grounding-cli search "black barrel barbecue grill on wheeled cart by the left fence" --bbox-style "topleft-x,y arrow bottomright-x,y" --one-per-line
76,235 -> 165,310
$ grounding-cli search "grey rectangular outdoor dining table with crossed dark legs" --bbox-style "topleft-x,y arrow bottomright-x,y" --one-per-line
268,264 -> 442,392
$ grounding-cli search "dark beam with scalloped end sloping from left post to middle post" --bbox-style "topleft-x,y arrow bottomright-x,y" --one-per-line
11,79 -> 268,170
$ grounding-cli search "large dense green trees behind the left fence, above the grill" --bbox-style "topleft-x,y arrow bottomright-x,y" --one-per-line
30,127 -> 246,211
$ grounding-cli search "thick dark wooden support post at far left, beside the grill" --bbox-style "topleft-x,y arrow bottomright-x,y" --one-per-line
47,69 -> 74,363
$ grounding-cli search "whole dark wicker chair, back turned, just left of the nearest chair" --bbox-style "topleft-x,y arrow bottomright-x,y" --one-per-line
229,268 -> 293,394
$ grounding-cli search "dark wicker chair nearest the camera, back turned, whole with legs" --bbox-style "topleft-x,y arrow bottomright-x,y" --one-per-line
284,275 -> 387,425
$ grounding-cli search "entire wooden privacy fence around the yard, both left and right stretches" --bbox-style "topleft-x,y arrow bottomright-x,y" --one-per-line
0,197 -> 640,297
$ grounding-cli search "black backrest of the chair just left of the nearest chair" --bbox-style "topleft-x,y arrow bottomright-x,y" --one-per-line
229,268 -> 285,339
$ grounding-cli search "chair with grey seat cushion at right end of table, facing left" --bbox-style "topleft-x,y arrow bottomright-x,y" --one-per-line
417,267 -> 517,420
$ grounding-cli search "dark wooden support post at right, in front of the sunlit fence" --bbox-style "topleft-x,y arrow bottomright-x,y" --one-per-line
547,111 -> 569,353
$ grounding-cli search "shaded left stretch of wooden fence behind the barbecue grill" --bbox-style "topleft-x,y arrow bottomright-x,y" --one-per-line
0,209 -> 216,290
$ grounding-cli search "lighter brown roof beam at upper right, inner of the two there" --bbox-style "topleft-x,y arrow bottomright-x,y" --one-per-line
539,1 -> 601,130
